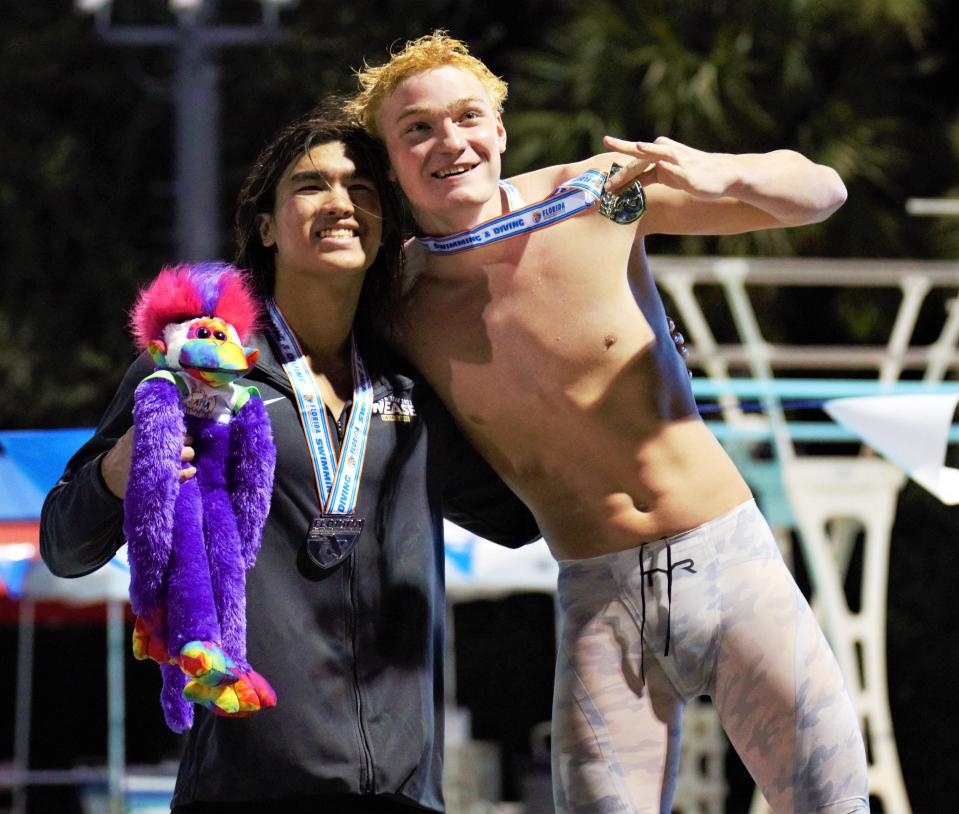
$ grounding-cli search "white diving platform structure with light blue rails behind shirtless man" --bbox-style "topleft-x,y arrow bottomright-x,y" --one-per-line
650,256 -> 959,814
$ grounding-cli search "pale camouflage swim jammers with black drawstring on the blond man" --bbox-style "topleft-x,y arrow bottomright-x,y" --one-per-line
553,501 -> 869,814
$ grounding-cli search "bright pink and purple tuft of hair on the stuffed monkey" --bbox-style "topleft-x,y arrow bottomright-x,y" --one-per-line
130,263 -> 261,350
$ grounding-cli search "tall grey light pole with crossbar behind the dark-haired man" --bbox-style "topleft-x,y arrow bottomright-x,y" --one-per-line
76,0 -> 296,261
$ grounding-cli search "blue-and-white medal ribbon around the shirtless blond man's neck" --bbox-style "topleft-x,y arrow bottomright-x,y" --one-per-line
417,170 -> 606,254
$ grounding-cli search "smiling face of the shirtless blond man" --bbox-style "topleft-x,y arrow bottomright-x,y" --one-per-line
377,67 -> 506,234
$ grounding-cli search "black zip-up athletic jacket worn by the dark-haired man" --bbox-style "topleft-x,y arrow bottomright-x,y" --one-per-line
40,338 -> 539,810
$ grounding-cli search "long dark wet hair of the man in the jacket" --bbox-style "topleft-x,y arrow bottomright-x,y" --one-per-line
234,103 -> 407,368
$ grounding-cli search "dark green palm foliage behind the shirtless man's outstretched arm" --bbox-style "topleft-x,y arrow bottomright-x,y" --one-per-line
508,0 -> 956,256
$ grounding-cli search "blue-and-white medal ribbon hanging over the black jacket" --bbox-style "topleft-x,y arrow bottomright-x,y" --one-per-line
267,300 -> 373,514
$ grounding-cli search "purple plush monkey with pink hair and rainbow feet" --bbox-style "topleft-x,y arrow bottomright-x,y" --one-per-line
124,263 -> 276,732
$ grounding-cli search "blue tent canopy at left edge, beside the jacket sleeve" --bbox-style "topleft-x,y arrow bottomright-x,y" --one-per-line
0,427 -> 93,521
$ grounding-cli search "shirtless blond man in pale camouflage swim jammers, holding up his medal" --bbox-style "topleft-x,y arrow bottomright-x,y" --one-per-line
353,32 -> 868,814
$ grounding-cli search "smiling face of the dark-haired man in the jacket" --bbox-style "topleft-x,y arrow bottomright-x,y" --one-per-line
257,141 -> 383,290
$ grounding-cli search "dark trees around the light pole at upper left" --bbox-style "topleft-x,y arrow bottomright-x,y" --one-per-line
0,0 -> 551,428
